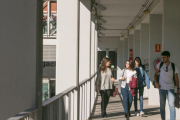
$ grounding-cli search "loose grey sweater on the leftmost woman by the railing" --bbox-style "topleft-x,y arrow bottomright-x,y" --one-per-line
95,68 -> 112,91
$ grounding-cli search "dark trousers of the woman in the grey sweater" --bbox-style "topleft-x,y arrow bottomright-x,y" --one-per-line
100,90 -> 110,114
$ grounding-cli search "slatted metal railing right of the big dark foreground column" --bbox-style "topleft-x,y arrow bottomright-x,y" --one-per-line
43,73 -> 97,120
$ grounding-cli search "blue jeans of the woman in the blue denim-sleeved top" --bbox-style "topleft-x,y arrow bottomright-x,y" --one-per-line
134,87 -> 144,112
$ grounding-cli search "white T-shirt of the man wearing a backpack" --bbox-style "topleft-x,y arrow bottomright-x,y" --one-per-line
156,62 -> 178,90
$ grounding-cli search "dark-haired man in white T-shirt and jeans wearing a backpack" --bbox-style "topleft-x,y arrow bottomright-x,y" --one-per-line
154,51 -> 179,120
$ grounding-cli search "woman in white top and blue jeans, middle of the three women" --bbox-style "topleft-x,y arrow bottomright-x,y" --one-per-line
119,60 -> 137,120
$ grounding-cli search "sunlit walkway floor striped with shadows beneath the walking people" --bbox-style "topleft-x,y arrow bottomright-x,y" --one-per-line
91,88 -> 160,120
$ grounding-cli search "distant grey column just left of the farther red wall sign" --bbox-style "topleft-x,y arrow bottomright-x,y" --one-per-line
123,38 -> 129,65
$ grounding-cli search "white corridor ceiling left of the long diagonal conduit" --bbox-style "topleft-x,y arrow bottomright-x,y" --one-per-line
96,0 -> 146,36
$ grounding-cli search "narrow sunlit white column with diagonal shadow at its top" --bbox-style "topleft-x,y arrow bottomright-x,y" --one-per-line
79,0 -> 91,82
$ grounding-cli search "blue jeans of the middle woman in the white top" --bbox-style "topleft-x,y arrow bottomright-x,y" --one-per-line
121,84 -> 133,113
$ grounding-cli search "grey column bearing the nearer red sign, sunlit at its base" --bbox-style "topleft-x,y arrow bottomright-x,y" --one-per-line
149,14 -> 162,105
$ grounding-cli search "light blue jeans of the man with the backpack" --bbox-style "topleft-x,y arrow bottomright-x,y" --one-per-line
159,89 -> 176,120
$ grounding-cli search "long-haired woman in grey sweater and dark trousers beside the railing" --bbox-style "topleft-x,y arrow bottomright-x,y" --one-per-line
95,57 -> 115,118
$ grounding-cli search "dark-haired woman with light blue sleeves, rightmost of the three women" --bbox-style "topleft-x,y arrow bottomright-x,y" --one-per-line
134,57 -> 150,117
